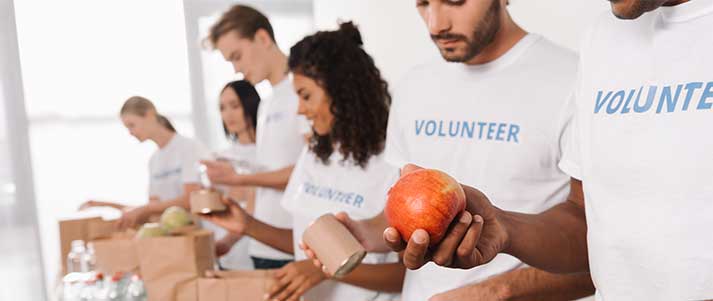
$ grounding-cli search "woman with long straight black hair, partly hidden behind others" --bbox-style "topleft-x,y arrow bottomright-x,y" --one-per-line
204,80 -> 260,270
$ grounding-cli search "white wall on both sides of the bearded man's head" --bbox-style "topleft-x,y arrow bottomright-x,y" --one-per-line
314,0 -> 608,83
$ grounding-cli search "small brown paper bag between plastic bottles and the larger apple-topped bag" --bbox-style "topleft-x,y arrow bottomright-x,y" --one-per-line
91,231 -> 139,275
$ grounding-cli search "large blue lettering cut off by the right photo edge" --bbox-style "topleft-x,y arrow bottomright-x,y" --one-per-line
594,81 -> 713,115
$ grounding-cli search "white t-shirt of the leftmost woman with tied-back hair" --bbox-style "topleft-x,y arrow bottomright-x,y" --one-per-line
149,134 -> 210,201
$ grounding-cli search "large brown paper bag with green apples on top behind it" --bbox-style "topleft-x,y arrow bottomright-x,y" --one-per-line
136,230 -> 215,301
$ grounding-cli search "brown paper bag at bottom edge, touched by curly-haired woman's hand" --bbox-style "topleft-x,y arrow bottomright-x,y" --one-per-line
198,270 -> 274,301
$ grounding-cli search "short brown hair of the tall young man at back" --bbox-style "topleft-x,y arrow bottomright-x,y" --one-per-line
208,4 -> 276,47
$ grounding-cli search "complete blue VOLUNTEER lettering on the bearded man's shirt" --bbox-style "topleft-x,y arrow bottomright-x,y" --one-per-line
414,119 -> 520,143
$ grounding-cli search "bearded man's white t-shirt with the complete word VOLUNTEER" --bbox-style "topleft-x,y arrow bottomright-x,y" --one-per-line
386,34 -> 577,301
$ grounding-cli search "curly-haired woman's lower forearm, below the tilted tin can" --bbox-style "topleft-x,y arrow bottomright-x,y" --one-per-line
337,262 -> 406,293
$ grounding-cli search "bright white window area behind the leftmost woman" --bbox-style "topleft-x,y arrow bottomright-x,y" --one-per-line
13,0 -> 193,290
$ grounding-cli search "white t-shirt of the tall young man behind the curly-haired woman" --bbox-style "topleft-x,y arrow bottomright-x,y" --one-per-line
250,77 -> 312,260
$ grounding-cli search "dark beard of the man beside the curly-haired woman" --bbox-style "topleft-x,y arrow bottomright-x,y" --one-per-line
431,0 -> 501,63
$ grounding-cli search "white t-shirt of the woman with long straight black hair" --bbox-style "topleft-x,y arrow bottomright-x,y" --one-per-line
203,142 -> 256,270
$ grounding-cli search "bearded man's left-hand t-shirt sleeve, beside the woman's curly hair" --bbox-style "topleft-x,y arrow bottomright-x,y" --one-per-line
384,86 -> 409,168
